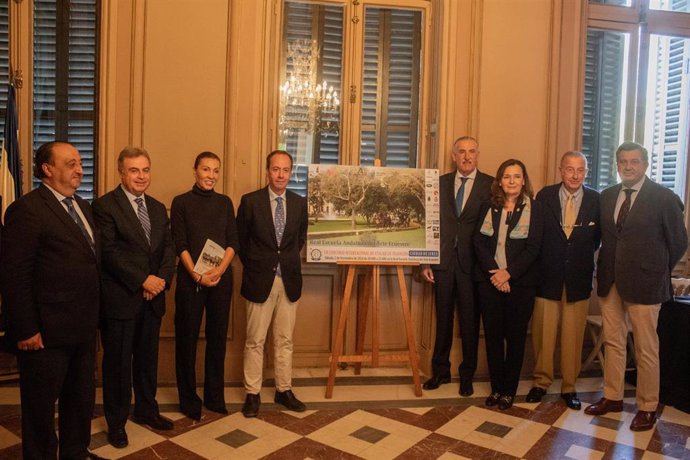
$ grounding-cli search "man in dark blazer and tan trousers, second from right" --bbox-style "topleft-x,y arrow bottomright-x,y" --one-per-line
527,151 -> 601,410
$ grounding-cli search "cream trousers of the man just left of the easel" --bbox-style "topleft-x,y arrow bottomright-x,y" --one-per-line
244,276 -> 297,394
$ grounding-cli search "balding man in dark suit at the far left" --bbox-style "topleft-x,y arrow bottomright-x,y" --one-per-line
0,142 -> 104,459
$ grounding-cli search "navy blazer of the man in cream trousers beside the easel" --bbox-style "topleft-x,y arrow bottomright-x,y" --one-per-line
237,187 -> 308,303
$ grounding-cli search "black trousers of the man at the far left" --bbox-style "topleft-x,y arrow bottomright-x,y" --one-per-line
17,337 -> 96,460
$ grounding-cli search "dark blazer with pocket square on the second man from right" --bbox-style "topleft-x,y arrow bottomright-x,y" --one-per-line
537,183 -> 601,302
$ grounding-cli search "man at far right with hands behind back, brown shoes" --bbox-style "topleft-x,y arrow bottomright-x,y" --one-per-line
585,142 -> 688,431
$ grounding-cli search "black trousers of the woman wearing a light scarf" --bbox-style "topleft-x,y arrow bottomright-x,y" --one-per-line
478,280 -> 536,396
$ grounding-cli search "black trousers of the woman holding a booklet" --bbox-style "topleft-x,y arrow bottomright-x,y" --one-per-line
175,270 -> 232,414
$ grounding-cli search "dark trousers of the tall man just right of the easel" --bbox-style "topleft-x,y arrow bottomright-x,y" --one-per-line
431,257 -> 480,381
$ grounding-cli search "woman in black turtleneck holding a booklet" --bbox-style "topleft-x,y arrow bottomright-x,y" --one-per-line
170,152 -> 239,420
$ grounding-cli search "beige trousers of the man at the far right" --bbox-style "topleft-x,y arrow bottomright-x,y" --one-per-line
599,284 -> 661,412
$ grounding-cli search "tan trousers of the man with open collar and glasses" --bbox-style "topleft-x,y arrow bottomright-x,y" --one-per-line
532,287 -> 589,393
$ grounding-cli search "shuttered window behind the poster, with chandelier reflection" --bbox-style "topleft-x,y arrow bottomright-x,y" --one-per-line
276,0 -> 429,194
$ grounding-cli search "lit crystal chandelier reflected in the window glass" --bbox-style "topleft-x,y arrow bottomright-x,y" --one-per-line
278,39 -> 340,137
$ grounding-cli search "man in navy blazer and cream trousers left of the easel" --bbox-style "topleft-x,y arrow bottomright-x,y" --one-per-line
237,150 -> 308,417
